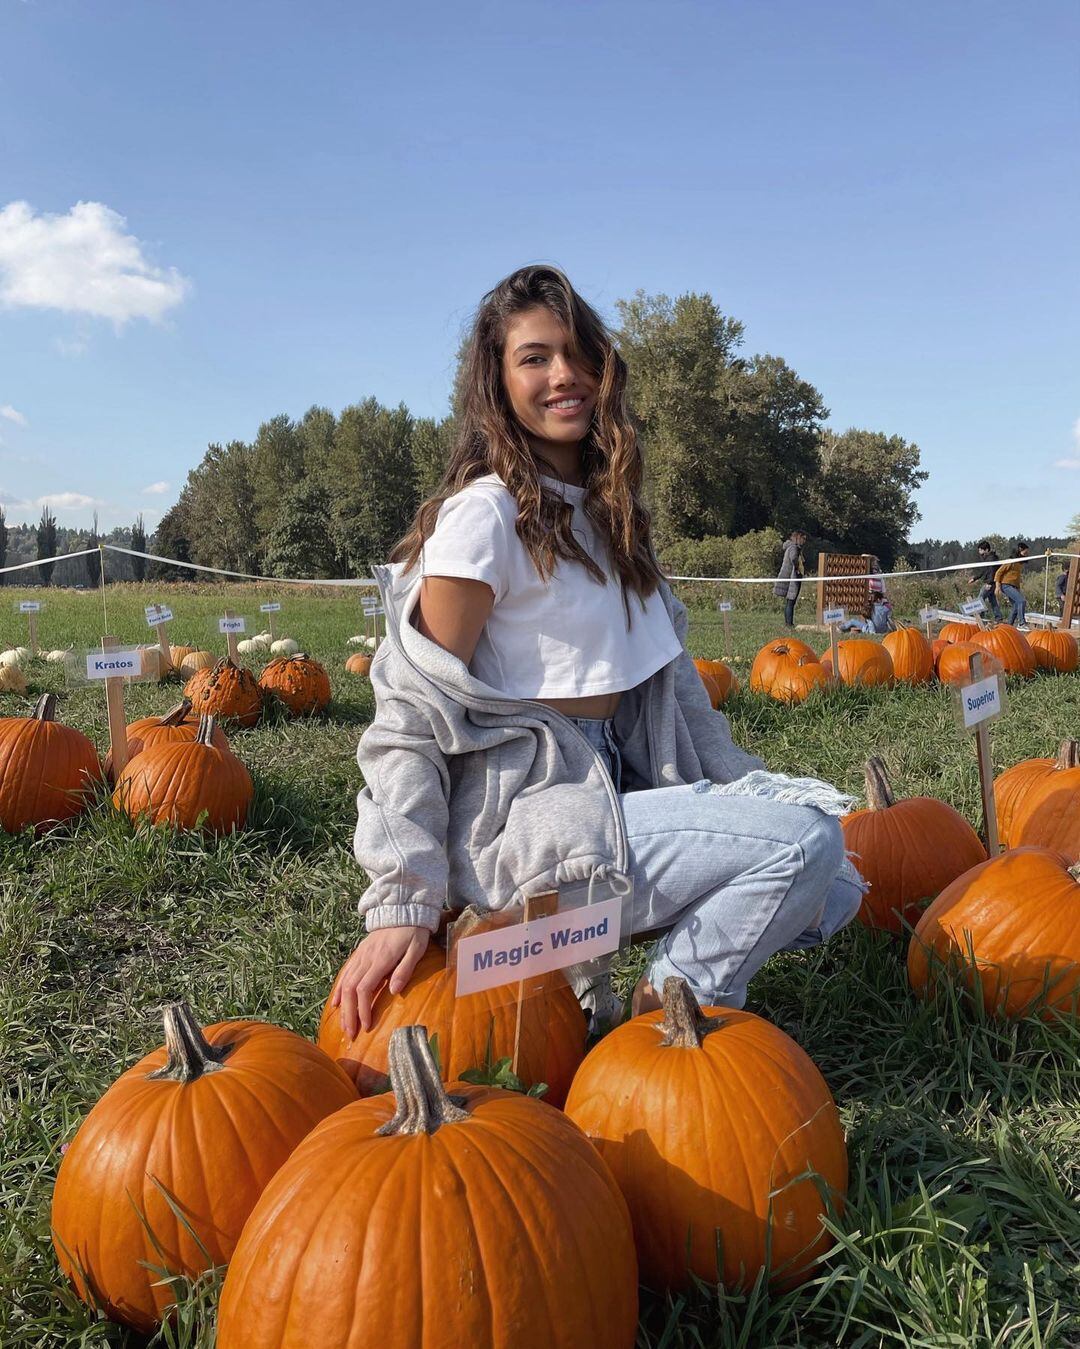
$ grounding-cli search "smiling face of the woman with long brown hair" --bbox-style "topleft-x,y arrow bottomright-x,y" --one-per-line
503,306 -> 597,445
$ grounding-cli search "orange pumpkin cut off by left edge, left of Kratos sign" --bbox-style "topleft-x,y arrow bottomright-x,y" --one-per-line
0,693 -> 101,834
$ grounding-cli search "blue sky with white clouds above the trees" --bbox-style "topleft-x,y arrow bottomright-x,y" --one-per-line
0,0 -> 1080,538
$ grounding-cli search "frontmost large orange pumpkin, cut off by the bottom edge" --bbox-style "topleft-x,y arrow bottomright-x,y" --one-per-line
217,1027 -> 638,1349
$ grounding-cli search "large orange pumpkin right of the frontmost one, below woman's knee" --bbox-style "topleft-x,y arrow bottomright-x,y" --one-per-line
566,977 -> 848,1290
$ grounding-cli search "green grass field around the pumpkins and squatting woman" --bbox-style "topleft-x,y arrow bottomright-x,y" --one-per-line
0,585 -> 1080,1349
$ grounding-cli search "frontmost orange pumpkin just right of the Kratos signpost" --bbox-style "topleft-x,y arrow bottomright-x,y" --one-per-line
112,716 -> 255,834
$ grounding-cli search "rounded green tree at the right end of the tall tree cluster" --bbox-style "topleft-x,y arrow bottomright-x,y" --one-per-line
808,428 -> 927,568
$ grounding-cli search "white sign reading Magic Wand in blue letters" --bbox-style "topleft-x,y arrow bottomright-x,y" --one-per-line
454,897 -> 623,997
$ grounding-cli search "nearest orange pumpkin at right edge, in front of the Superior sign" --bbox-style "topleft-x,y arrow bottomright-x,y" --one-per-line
907,847 -> 1080,1016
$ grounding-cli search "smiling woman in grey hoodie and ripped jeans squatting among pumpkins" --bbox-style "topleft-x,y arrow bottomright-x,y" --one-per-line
337,267 -> 862,1036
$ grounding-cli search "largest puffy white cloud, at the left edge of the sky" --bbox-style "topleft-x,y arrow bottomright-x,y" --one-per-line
0,201 -> 190,325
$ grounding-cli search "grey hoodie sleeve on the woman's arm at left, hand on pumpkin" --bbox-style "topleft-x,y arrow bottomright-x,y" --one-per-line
353,657 -> 450,932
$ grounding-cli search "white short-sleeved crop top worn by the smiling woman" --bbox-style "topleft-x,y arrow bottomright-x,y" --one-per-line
421,473 -> 682,699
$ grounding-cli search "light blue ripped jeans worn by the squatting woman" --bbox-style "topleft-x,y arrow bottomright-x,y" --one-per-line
563,716 -> 862,1008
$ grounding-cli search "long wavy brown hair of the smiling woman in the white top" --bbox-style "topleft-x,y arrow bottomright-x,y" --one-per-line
390,266 -> 661,616
